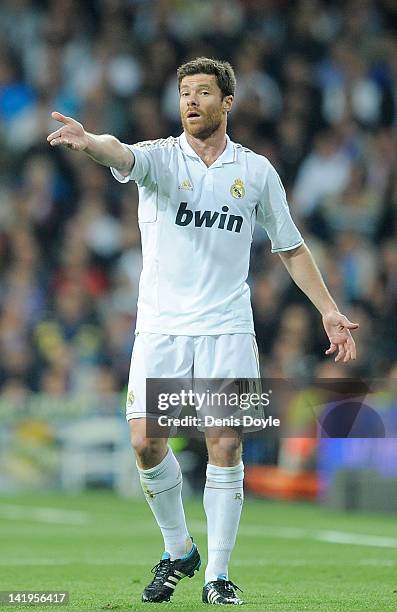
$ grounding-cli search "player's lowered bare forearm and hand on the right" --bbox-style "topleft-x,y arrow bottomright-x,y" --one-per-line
279,244 -> 358,362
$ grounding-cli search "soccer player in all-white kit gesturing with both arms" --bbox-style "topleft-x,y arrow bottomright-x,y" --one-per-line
48,58 -> 358,604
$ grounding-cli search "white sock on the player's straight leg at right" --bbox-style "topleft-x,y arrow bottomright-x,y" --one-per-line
204,461 -> 244,583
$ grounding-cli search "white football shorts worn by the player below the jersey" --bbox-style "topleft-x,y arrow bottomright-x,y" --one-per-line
126,332 -> 260,421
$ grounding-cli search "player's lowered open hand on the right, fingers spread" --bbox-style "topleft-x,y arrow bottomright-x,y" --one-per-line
323,310 -> 358,363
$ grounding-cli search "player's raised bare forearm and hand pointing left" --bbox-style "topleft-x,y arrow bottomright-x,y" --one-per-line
47,112 -> 135,176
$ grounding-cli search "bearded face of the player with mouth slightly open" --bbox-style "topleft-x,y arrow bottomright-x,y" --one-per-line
179,74 -> 233,140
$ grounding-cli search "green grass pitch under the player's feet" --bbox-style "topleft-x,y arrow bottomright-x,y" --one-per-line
0,492 -> 397,612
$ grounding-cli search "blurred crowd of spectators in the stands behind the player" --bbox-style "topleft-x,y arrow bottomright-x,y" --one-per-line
0,0 -> 397,398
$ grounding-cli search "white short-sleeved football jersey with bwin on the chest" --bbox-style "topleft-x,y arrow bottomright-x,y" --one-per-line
111,134 -> 303,335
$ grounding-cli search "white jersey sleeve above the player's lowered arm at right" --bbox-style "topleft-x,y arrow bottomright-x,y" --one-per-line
257,164 -> 303,253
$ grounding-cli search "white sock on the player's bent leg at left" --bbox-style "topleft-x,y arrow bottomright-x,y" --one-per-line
137,448 -> 192,559
